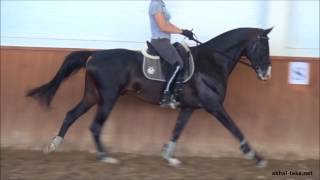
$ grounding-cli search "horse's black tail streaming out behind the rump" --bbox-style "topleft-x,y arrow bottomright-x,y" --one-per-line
26,51 -> 93,107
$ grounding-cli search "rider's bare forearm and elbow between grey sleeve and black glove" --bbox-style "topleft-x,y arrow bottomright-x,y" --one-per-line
154,12 -> 182,34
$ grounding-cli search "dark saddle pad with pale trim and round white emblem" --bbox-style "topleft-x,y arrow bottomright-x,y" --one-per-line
141,41 -> 194,83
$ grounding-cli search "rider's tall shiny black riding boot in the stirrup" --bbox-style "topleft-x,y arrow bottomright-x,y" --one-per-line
160,65 -> 181,109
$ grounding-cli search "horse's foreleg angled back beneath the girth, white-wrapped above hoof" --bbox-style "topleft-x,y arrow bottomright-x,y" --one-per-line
162,108 -> 193,166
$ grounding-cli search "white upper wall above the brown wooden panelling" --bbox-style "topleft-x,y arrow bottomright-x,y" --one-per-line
1,0 -> 319,57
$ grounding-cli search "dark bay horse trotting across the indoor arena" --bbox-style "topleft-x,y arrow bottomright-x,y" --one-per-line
27,28 -> 272,166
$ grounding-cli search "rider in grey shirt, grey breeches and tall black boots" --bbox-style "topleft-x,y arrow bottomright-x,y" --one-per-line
149,0 -> 193,106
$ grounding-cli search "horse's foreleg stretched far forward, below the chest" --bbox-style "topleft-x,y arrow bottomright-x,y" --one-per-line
206,105 -> 267,167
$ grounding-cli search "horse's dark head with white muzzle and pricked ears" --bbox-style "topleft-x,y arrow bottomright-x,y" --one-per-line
244,28 -> 272,81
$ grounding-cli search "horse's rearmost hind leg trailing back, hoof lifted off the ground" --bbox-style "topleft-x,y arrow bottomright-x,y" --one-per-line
44,74 -> 98,153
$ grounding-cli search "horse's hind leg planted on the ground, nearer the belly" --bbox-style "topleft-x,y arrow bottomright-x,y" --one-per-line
90,90 -> 119,163
